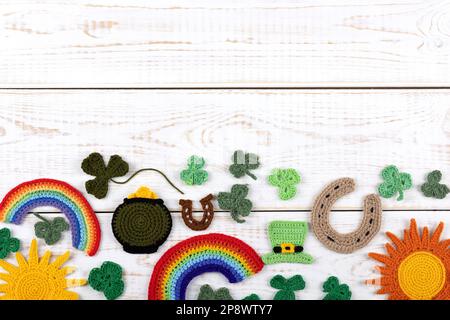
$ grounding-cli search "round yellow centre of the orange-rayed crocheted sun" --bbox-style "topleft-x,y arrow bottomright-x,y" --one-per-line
398,251 -> 446,300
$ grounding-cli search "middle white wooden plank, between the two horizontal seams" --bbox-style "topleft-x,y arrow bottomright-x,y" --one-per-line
0,90 -> 450,211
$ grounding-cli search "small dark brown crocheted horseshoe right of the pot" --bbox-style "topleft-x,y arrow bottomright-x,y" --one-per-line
180,194 -> 214,231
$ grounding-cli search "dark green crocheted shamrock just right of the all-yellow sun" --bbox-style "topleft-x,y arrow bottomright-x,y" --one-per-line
88,261 -> 125,300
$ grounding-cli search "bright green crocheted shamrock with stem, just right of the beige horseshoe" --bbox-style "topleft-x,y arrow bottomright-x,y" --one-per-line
378,165 -> 412,201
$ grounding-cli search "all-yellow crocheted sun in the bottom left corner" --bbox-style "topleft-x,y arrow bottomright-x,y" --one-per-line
0,240 -> 86,300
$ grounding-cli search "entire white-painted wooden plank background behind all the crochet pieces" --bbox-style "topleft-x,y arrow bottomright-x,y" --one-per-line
0,0 -> 450,299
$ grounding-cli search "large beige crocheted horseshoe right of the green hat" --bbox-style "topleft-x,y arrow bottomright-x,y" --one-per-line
311,178 -> 382,253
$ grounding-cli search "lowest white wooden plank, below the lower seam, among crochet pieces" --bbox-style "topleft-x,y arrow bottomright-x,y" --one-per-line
1,212 -> 450,300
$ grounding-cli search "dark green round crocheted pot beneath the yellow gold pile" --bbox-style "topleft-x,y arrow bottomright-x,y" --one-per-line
112,190 -> 172,253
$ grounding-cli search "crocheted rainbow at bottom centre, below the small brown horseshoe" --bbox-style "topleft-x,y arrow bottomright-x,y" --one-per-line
148,233 -> 264,300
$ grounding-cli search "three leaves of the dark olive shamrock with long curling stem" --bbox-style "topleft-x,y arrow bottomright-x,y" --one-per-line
81,152 -> 129,199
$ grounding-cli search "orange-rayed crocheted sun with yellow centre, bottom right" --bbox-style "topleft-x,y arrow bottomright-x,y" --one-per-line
366,219 -> 450,300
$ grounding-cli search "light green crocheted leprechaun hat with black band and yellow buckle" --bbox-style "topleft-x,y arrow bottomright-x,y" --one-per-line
262,221 -> 314,264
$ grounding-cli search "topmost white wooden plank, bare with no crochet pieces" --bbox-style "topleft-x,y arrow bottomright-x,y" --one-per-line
0,0 -> 450,88
